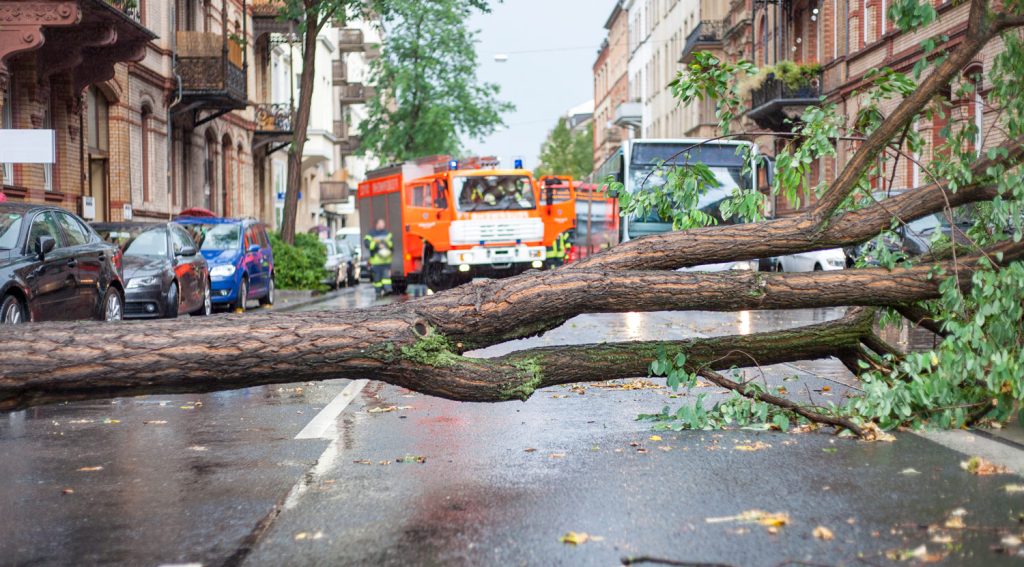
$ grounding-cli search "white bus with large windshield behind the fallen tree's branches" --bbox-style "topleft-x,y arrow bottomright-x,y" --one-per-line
577,138 -> 770,270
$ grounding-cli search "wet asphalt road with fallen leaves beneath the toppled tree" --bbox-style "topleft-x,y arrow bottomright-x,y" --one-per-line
0,286 -> 1024,565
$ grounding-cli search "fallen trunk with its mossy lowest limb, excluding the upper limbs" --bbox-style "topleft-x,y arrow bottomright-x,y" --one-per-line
0,310 -> 872,410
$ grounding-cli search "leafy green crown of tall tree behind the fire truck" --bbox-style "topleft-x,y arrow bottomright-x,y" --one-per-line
359,0 -> 514,163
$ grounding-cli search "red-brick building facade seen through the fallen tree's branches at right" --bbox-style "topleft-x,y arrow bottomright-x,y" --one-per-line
746,0 -> 1002,215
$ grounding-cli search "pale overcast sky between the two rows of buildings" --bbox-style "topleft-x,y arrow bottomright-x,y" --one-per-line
464,0 -> 614,169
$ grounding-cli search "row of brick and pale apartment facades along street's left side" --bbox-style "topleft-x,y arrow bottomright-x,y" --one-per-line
0,0 -> 379,235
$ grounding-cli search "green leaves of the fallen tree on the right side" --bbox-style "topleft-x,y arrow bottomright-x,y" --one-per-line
613,0 -> 1024,429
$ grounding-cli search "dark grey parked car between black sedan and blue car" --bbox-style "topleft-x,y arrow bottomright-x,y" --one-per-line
92,222 -> 213,318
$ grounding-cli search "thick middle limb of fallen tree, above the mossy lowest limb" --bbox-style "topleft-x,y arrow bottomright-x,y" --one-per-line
411,239 -> 1024,352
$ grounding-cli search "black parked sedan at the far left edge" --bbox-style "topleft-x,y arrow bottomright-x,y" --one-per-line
0,203 -> 124,323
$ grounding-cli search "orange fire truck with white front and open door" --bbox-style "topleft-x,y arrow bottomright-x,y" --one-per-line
357,156 -> 575,293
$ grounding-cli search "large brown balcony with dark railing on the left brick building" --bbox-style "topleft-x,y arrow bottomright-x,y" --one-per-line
177,32 -> 247,112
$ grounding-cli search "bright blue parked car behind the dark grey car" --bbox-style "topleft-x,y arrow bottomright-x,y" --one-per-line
175,217 -> 274,311
